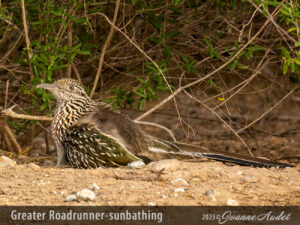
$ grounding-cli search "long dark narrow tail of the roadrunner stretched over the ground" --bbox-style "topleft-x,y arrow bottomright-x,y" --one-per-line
149,139 -> 293,168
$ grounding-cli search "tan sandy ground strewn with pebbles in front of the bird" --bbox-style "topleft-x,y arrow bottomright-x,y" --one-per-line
0,156 -> 300,206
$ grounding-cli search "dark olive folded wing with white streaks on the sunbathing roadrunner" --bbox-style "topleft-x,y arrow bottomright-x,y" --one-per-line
63,122 -> 140,168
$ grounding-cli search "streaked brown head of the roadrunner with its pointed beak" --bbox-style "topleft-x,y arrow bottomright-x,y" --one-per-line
36,78 -> 89,102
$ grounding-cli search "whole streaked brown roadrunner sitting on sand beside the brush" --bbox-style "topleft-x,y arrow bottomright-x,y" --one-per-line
37,79 -> 289,168
